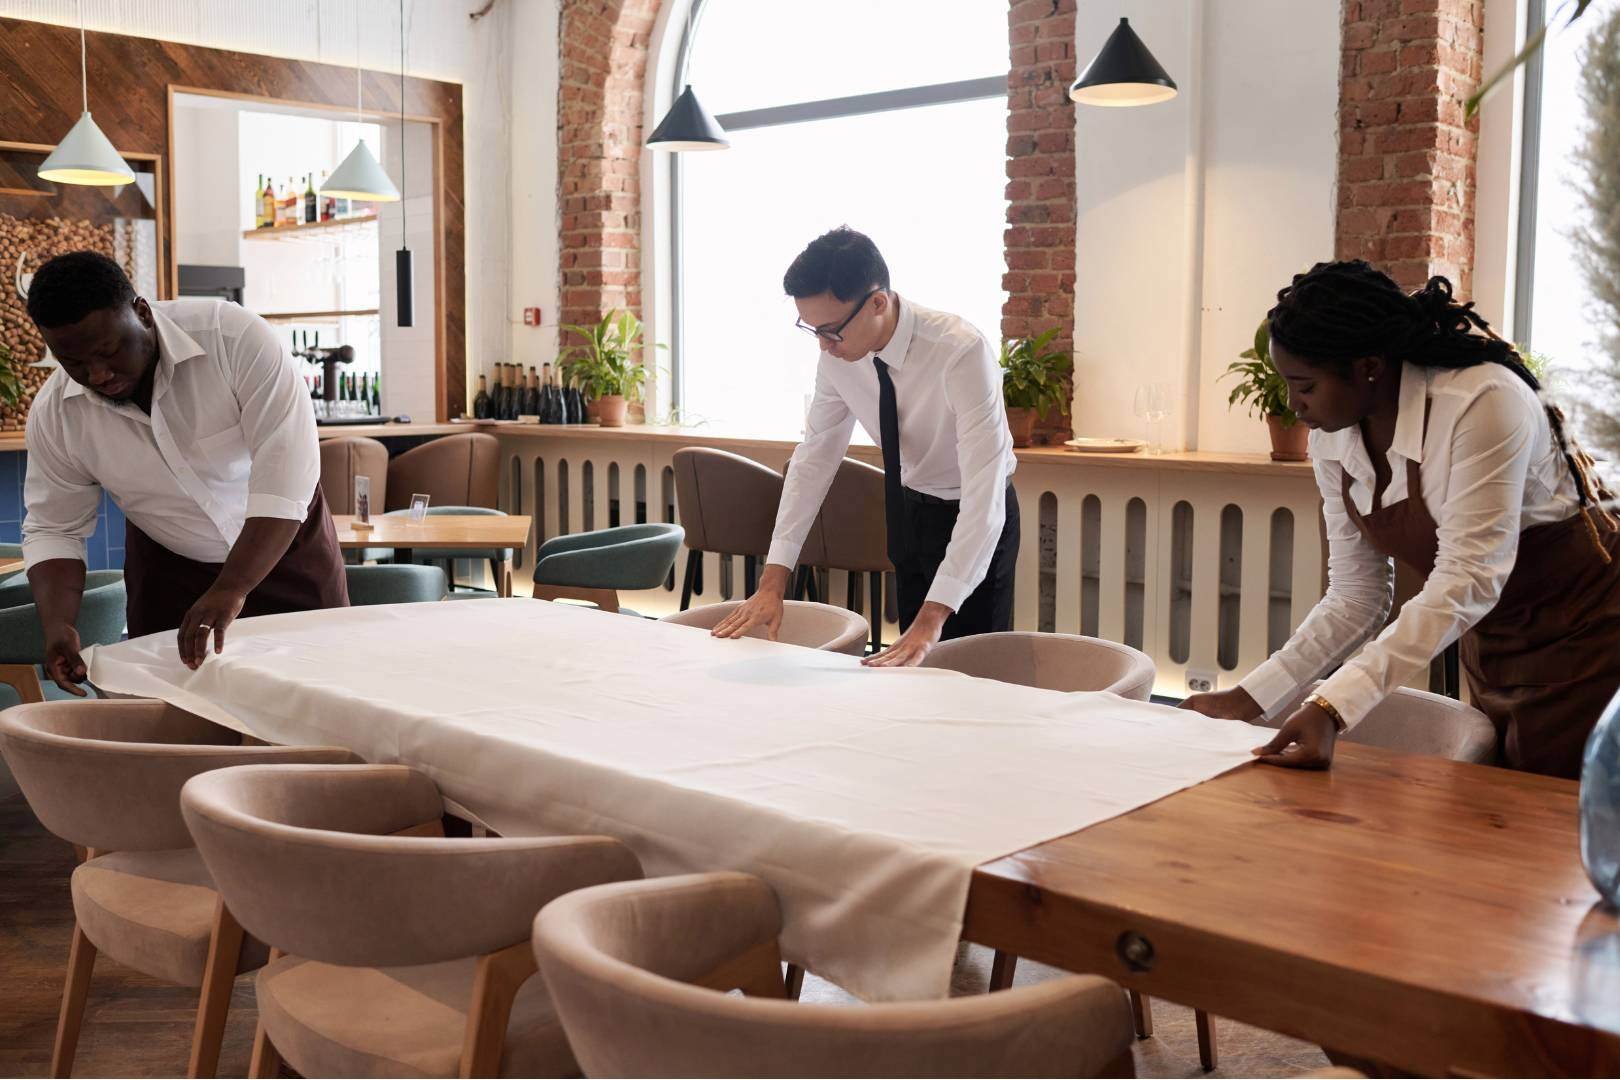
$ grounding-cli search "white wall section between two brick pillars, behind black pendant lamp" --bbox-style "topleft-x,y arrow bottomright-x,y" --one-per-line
1074,0 -> 1340,452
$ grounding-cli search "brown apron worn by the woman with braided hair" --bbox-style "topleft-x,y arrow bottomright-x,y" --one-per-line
1343,461 -> 1620,779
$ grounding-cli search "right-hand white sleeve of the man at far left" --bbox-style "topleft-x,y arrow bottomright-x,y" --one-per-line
227,316 -> 321,521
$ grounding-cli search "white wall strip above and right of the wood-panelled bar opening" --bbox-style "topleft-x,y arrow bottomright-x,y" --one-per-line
0,0 -> 544,417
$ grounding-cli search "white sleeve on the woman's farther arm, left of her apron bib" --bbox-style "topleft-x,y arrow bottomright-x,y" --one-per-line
1238,458 -> 1393,721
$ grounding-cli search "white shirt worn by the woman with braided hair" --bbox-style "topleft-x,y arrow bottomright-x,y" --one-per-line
1239,363 -> 1580,725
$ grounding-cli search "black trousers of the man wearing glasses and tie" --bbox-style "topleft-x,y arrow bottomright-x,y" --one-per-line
889,484 -> 1019,641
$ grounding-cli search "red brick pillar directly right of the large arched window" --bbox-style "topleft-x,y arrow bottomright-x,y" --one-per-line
1001,0 -> 1076,440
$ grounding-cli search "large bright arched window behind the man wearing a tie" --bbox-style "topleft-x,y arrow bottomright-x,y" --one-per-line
671,0 -> 1008,437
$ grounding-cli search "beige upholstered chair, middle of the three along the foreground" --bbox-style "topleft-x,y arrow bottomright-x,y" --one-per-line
180,766 -> 642,1077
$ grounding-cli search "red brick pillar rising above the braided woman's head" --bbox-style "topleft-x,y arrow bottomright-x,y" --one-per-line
1335,0 -> 1484,296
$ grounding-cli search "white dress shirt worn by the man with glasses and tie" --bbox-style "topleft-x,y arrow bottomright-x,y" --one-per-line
766,293 -> 1017,610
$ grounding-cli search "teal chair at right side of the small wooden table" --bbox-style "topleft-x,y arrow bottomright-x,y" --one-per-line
535,523 -> 685,614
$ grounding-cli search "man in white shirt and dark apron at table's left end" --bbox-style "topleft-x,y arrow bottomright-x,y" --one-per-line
23,251 -> 348,693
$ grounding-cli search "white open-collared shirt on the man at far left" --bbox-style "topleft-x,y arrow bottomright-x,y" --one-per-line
23,300 -> 321,567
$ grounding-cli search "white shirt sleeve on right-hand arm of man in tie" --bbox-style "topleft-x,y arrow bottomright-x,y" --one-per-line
928,338 -> 1013,610
